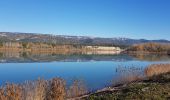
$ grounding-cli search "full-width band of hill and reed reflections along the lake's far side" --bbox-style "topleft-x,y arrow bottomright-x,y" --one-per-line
0,51 -> 170,62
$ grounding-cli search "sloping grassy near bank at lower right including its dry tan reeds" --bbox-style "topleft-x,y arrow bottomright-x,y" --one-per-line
81,64 -> 170,100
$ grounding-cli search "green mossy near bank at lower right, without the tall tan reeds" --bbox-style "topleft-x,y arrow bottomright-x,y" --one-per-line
72,72 -> 170,100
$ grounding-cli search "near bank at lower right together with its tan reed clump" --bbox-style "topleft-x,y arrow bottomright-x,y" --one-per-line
70,64 -> 170,100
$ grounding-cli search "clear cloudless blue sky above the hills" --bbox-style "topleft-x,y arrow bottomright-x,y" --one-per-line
0,0 -> 170,40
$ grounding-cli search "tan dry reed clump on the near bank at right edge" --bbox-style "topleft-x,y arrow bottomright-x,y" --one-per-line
145,64 -> 170,77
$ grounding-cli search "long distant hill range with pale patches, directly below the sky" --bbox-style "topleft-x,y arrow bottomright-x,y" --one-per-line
0,32 -> 170,46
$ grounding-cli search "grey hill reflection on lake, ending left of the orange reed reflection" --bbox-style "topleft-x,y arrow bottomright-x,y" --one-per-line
0,52 -> 133,62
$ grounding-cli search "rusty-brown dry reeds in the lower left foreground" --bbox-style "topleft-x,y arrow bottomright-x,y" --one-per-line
0,78 -> 87,100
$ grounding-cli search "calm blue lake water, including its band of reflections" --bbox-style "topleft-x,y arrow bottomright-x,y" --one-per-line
0,53 -> 170,90
